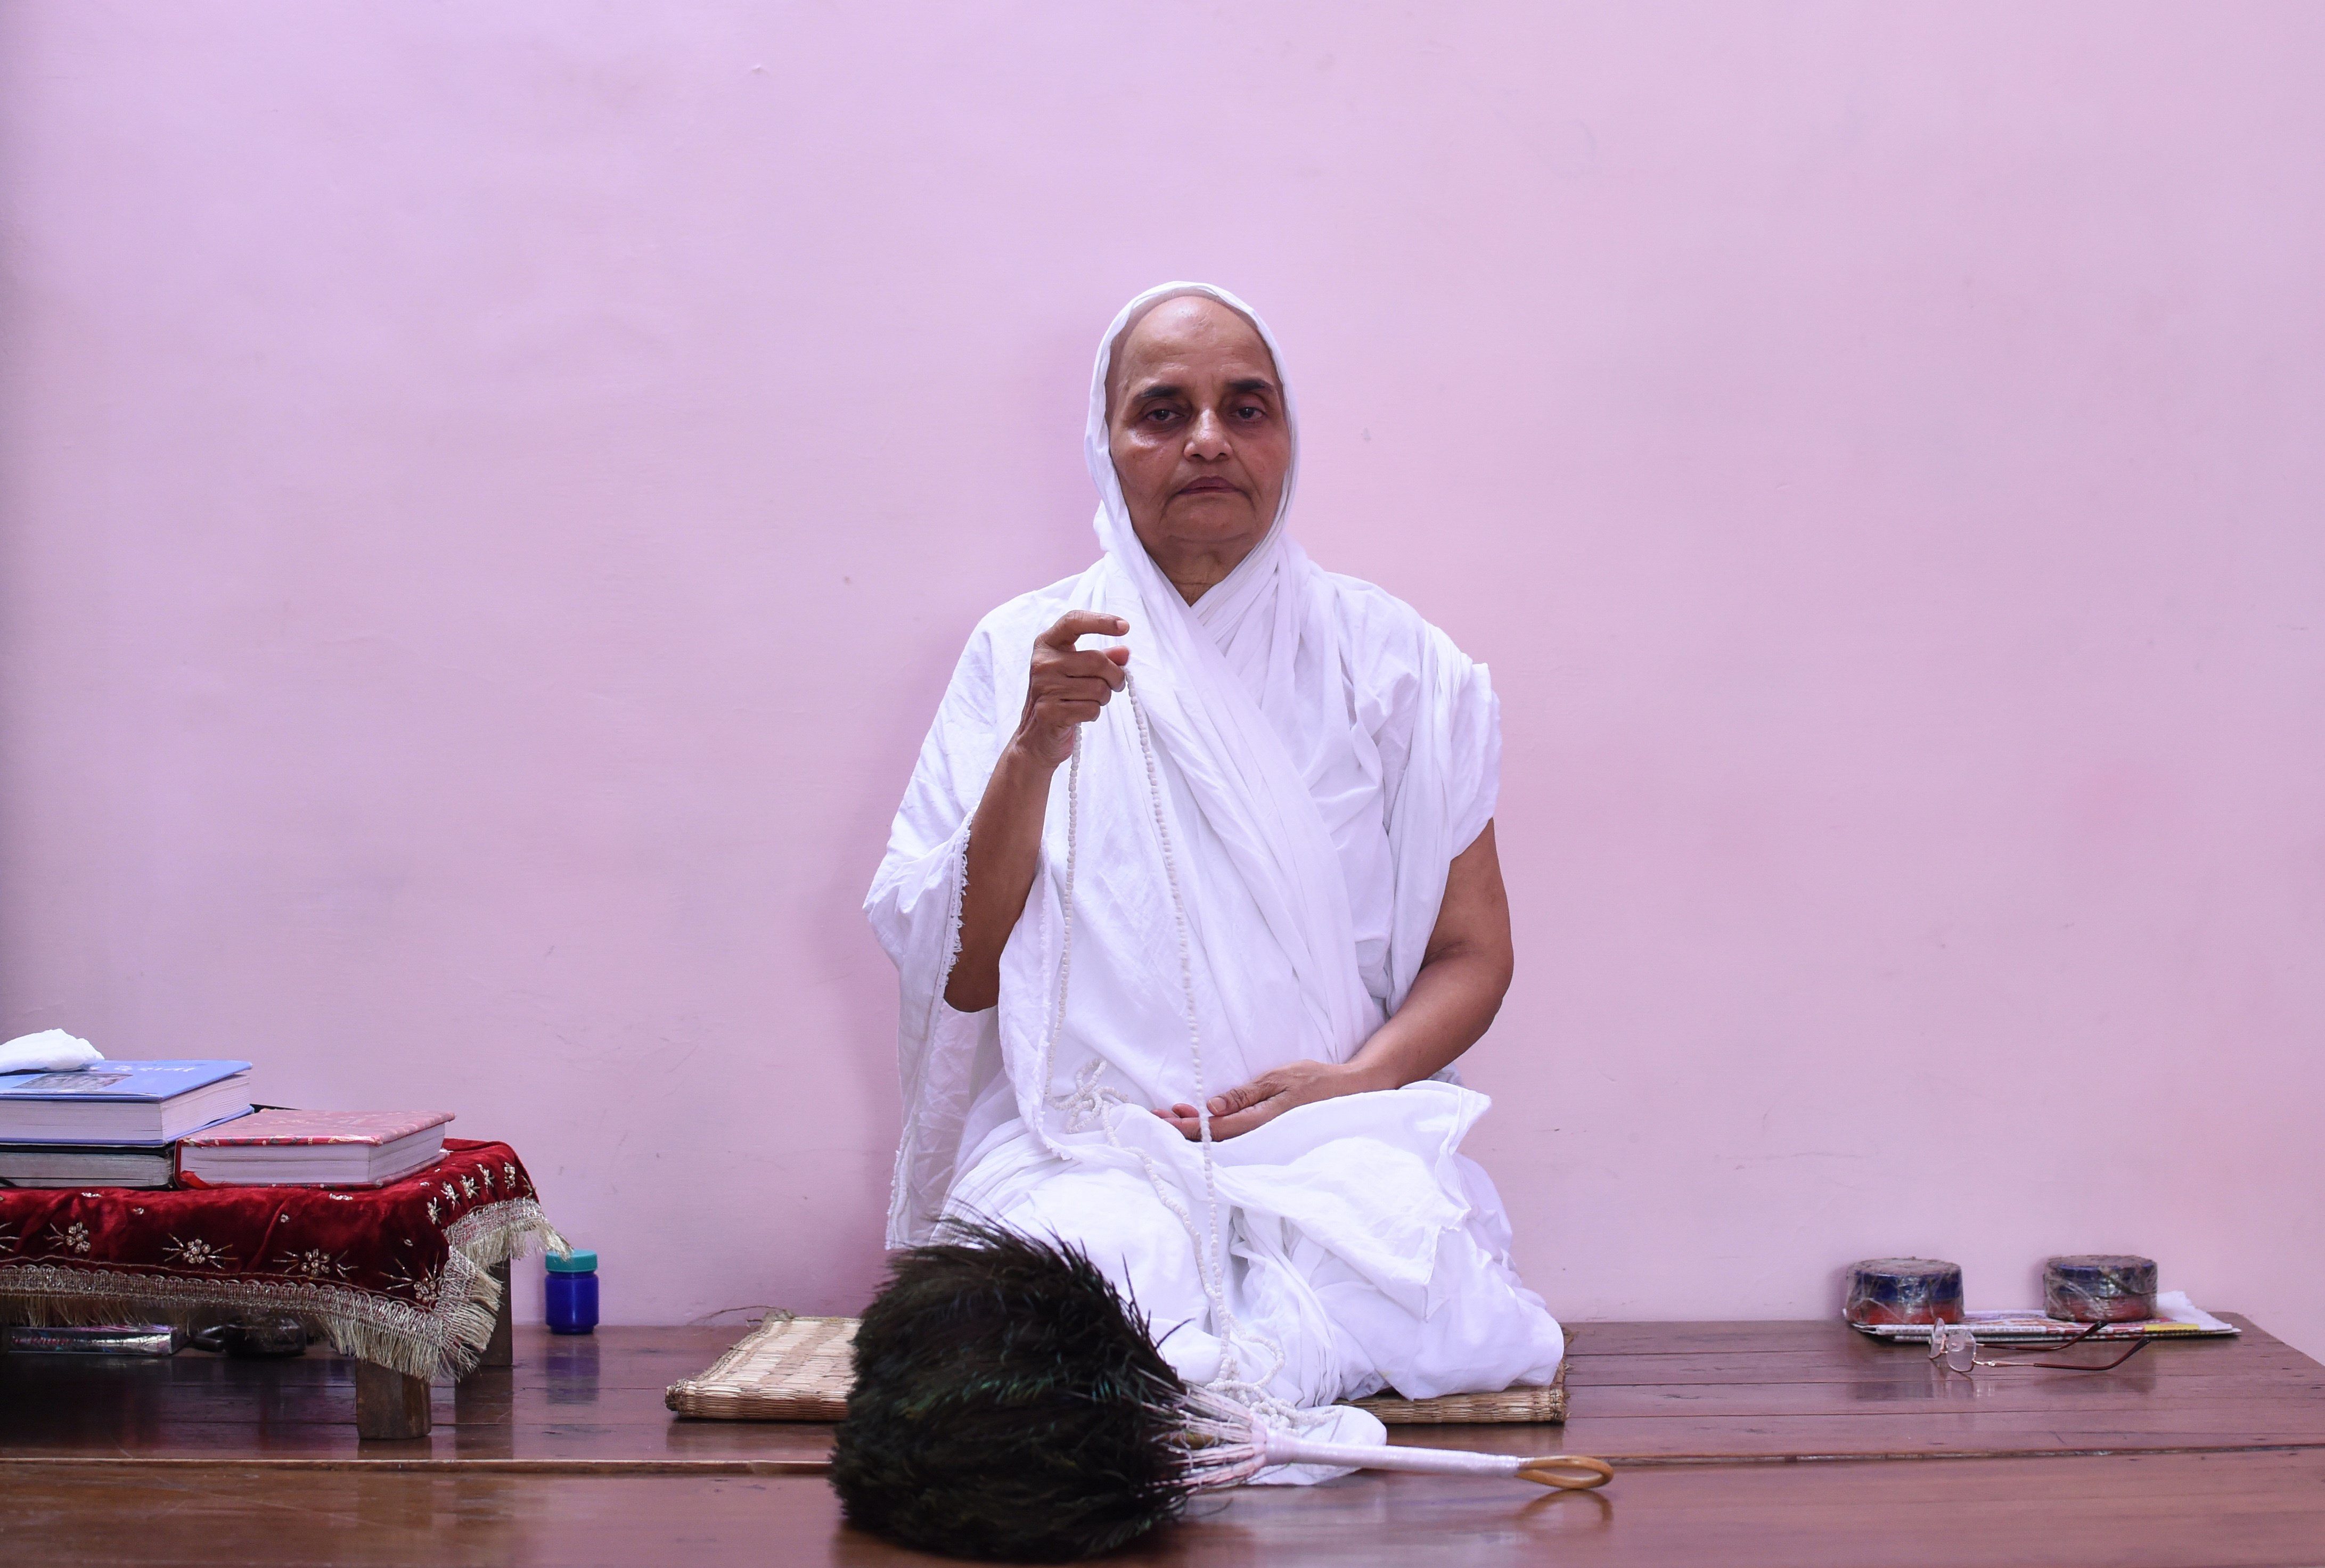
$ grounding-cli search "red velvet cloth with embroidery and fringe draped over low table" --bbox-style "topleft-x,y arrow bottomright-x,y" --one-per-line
0,1138 -> 553,1370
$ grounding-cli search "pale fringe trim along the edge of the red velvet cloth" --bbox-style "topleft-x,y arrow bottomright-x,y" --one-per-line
0,1198 -> 570,1382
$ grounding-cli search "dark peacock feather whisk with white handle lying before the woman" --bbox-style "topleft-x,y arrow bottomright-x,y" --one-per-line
832,1224 -> 1614,1563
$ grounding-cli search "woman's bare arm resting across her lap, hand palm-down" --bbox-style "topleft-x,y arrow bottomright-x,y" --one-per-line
1158,822 -> 1516,1138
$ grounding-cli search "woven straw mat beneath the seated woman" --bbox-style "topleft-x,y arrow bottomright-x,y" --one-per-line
662,1317 -> 1567,1426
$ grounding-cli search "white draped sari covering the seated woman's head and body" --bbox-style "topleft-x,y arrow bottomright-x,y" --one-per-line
865,283 -> 1565,1480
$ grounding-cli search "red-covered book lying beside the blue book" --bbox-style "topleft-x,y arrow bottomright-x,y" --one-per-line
177,1110 -> 451,1187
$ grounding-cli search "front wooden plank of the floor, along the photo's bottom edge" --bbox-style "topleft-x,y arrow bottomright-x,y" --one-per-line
13,1452 -> 2325,1568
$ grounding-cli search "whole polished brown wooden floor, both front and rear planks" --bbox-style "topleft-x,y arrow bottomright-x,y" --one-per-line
0,1324 -> 2325,1568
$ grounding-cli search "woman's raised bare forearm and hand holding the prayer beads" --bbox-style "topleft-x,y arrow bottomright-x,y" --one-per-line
944,611 -> 1130,1013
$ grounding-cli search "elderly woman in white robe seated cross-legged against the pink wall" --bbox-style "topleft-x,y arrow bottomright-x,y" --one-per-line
865,283 -> 1565,1480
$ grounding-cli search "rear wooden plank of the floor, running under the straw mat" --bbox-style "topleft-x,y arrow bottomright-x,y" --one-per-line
18,1324 -> 2325,1464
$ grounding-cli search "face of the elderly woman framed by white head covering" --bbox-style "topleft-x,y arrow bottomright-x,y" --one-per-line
1107,295 -> 1292,569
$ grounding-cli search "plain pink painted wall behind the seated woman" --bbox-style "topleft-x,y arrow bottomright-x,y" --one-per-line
0,0 -> 2325,1352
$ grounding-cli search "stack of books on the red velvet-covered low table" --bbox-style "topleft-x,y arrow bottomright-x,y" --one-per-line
0,1062 -> 451,1187
